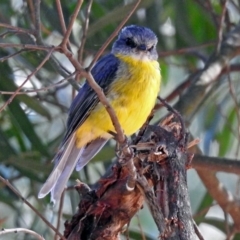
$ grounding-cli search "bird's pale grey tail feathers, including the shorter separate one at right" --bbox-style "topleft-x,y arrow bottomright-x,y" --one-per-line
38,135 -> 108,203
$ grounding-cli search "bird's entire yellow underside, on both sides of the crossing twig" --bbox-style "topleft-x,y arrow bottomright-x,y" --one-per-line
76,56 -> 161,147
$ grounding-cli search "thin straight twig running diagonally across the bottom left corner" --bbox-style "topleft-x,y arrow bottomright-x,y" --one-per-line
0,176 -> 66,240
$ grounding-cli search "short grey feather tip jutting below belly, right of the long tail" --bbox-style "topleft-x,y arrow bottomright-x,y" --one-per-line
76,138 -> 108,171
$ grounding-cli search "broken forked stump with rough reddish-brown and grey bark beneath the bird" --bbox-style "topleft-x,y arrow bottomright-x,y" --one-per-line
64,113 -> 196,240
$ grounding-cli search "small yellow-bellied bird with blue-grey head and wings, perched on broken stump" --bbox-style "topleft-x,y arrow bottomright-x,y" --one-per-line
38,25 -> 161,203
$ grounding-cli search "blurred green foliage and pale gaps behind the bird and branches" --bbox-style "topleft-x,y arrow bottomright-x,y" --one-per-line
0,0 -> 240,240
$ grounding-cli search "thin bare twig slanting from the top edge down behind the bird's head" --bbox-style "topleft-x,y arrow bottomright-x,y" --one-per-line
88,0 -> 141,71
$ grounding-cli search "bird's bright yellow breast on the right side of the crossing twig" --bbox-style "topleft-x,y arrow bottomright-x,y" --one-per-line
110,56 -> 160,135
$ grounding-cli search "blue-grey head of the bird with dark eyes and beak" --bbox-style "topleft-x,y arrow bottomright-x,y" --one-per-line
112,25 -> 158,60
